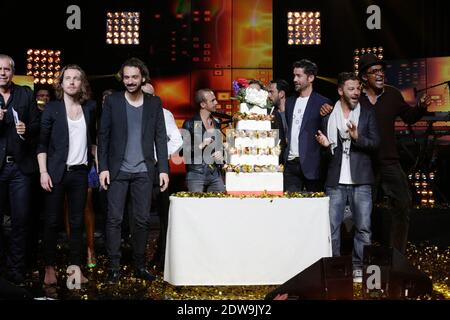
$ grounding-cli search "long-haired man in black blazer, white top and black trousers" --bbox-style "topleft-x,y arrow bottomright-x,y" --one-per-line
37,64 -> 97,285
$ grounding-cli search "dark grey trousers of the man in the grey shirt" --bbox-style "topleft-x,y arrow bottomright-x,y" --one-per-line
106,171 -> 153,270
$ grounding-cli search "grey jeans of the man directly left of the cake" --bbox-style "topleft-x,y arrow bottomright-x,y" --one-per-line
186,166 -> 225,192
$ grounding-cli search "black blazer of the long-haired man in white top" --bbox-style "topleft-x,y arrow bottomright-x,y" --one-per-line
37,100 -> 97,183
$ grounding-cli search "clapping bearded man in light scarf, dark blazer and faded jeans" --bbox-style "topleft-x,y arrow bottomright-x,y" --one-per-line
316,72 -> 380,282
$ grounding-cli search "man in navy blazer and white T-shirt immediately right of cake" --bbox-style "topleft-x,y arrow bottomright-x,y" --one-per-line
284,59 -> 331,192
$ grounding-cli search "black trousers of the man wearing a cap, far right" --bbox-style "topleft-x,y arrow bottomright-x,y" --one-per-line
374,163 -> 412,253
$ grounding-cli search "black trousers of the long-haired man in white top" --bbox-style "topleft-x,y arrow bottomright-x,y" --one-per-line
44,166 -> 88,266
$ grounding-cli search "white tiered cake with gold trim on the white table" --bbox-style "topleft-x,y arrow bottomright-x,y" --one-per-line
225,103 -> 283,195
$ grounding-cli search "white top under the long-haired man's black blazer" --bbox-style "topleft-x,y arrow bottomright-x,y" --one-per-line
66,114 -> 87,166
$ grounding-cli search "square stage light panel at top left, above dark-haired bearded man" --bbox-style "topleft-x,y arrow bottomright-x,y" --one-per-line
106,12 -> 140,45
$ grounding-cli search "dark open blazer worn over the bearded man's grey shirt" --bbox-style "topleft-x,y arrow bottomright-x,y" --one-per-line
98,91 -> 169,180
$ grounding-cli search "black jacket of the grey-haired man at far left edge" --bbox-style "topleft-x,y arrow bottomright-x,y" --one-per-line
0,84 -> 40,174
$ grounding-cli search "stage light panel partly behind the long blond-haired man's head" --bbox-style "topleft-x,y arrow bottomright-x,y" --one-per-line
26,49 -> 61,84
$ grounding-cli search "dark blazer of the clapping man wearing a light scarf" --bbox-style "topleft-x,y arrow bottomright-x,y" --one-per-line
323,105 -> 380,187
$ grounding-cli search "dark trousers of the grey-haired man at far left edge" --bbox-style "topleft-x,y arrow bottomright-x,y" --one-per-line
0,163 -> 31,281
